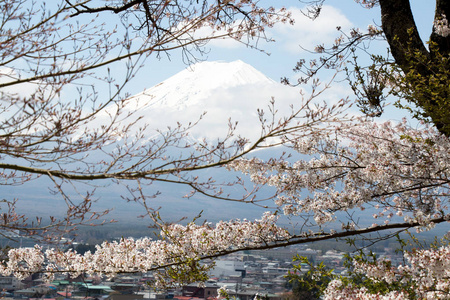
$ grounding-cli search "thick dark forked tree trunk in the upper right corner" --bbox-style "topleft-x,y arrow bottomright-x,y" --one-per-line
379,0 -> 450,137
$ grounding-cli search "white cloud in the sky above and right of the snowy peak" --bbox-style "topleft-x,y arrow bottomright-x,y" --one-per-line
269,5 -> 353,54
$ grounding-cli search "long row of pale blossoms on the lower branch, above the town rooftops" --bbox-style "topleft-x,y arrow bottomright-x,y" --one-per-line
0,213 -> 289,280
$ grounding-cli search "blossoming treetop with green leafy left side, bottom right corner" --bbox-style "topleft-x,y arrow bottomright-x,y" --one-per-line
287,234 -> 450,299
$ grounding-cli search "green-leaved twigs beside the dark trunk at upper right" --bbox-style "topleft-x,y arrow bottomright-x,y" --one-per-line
346,29 -> 450,136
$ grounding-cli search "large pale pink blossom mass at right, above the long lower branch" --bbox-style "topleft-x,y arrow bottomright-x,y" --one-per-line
232,118 -> 450,228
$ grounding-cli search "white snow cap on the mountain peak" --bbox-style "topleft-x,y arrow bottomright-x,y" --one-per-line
115,60 -> 300,139
